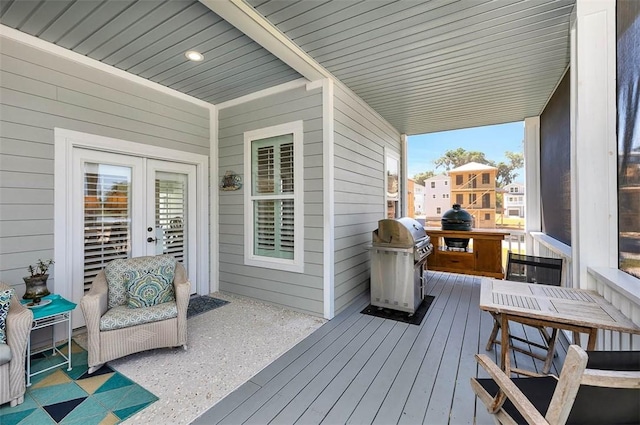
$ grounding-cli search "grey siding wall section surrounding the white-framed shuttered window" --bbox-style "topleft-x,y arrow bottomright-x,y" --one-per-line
218,87 -> 324,316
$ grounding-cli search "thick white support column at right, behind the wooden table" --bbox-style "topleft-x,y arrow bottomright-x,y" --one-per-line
571,0 -> 618,289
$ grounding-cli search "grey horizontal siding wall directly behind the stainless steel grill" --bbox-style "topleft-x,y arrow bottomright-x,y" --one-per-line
334,84 -> 400,314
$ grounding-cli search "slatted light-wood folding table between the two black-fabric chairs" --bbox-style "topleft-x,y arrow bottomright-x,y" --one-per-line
480,278 -> 640,375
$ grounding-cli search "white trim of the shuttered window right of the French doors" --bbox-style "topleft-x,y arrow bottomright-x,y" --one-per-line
243,121 -> 304,273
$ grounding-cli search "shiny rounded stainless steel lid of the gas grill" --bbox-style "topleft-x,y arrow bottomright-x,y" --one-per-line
372,217 -> 430,248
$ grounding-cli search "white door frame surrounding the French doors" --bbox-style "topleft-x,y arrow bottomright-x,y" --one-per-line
54,128 -> 210,310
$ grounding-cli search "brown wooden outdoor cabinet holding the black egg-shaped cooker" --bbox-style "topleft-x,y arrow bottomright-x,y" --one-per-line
425,227 -> 509,279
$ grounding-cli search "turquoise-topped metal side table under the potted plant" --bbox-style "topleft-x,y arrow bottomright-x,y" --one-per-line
20,294 -> 76,387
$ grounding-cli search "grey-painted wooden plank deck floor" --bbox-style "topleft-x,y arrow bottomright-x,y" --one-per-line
193,272 -> 566,425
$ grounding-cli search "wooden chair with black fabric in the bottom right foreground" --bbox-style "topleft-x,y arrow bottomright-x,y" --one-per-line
471,345 -> 640,425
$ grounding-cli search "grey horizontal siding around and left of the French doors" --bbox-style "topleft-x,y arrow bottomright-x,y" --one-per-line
0,37 -> 209,294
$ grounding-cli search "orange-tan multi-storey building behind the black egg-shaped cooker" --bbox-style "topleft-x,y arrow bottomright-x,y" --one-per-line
449,162 -> 498,229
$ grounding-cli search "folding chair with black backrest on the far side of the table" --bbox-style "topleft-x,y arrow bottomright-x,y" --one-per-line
486,252 -> 562,374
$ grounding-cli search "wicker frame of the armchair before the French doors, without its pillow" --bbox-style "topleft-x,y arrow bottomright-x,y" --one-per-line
80,257 -> 191,373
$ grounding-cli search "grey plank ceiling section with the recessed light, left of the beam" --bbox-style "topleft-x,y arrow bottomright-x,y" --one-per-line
0,0 -> 300,104
